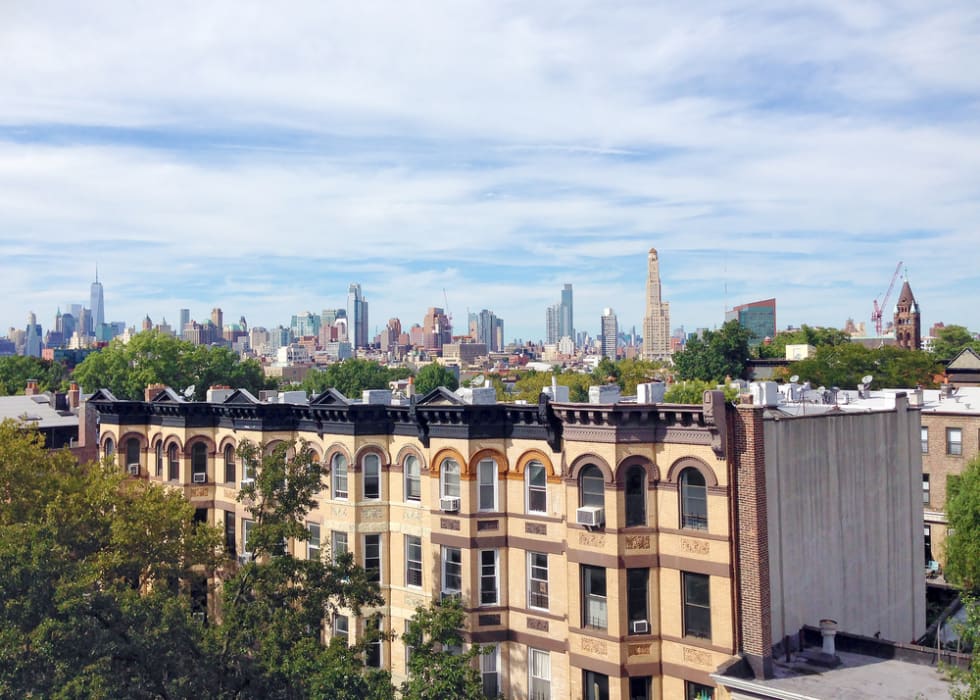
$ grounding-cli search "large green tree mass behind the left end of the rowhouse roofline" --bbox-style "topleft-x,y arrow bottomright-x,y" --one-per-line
73,331 -> 275,401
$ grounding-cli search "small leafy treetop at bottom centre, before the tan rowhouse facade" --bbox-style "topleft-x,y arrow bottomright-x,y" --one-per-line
401,598 -> 491,700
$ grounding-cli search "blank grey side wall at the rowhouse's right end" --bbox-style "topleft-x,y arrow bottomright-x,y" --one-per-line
764,397 -> 925,642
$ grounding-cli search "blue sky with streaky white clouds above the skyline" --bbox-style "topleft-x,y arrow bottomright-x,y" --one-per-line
0,0 -> 980,340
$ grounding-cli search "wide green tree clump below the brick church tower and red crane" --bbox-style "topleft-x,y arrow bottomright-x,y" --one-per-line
777,343 -> 940,389
